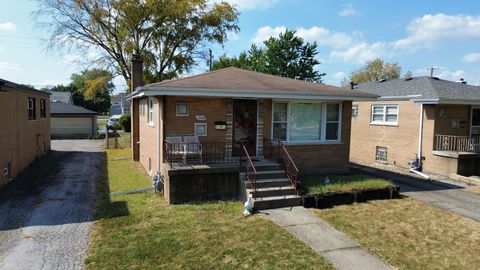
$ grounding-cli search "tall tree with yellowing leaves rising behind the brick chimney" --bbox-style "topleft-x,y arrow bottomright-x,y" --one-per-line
35,0 -> 239,91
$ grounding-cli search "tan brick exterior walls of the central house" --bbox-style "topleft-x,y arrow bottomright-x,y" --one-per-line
133,96 -> 352,175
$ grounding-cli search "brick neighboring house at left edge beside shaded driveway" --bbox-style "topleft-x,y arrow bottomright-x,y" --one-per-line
0,79 -> 50,186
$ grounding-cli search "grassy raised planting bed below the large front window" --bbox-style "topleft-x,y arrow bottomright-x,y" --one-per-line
300,175 -> 393,195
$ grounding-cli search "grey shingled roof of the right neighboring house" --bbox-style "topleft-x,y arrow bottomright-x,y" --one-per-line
355,77 -> 480,104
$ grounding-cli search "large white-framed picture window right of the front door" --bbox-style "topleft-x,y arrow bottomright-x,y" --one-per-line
272,102 -> 342,142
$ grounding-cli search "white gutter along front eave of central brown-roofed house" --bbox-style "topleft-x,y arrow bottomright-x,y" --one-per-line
127,86 -> 377,100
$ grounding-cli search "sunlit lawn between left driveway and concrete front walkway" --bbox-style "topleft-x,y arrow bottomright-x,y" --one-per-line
86,146 -> 333,269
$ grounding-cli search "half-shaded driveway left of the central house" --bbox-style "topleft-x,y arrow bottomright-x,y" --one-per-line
0,140 -> 104,269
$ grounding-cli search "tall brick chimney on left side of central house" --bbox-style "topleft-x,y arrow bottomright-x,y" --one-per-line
130,54 -> 143,161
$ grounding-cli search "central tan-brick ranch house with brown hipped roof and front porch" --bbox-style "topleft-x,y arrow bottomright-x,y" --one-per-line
129,58 -> 374,207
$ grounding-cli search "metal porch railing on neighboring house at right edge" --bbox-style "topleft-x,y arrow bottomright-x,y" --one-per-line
433,134 -> 480,153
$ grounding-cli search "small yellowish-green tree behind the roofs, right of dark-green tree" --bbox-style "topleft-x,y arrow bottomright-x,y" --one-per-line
350,58 -> 401,83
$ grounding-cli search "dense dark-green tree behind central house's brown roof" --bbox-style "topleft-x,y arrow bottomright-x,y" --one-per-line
212,30 -> 325,83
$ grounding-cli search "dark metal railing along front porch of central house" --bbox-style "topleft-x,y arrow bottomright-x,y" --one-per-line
163,141 -> 238,167
